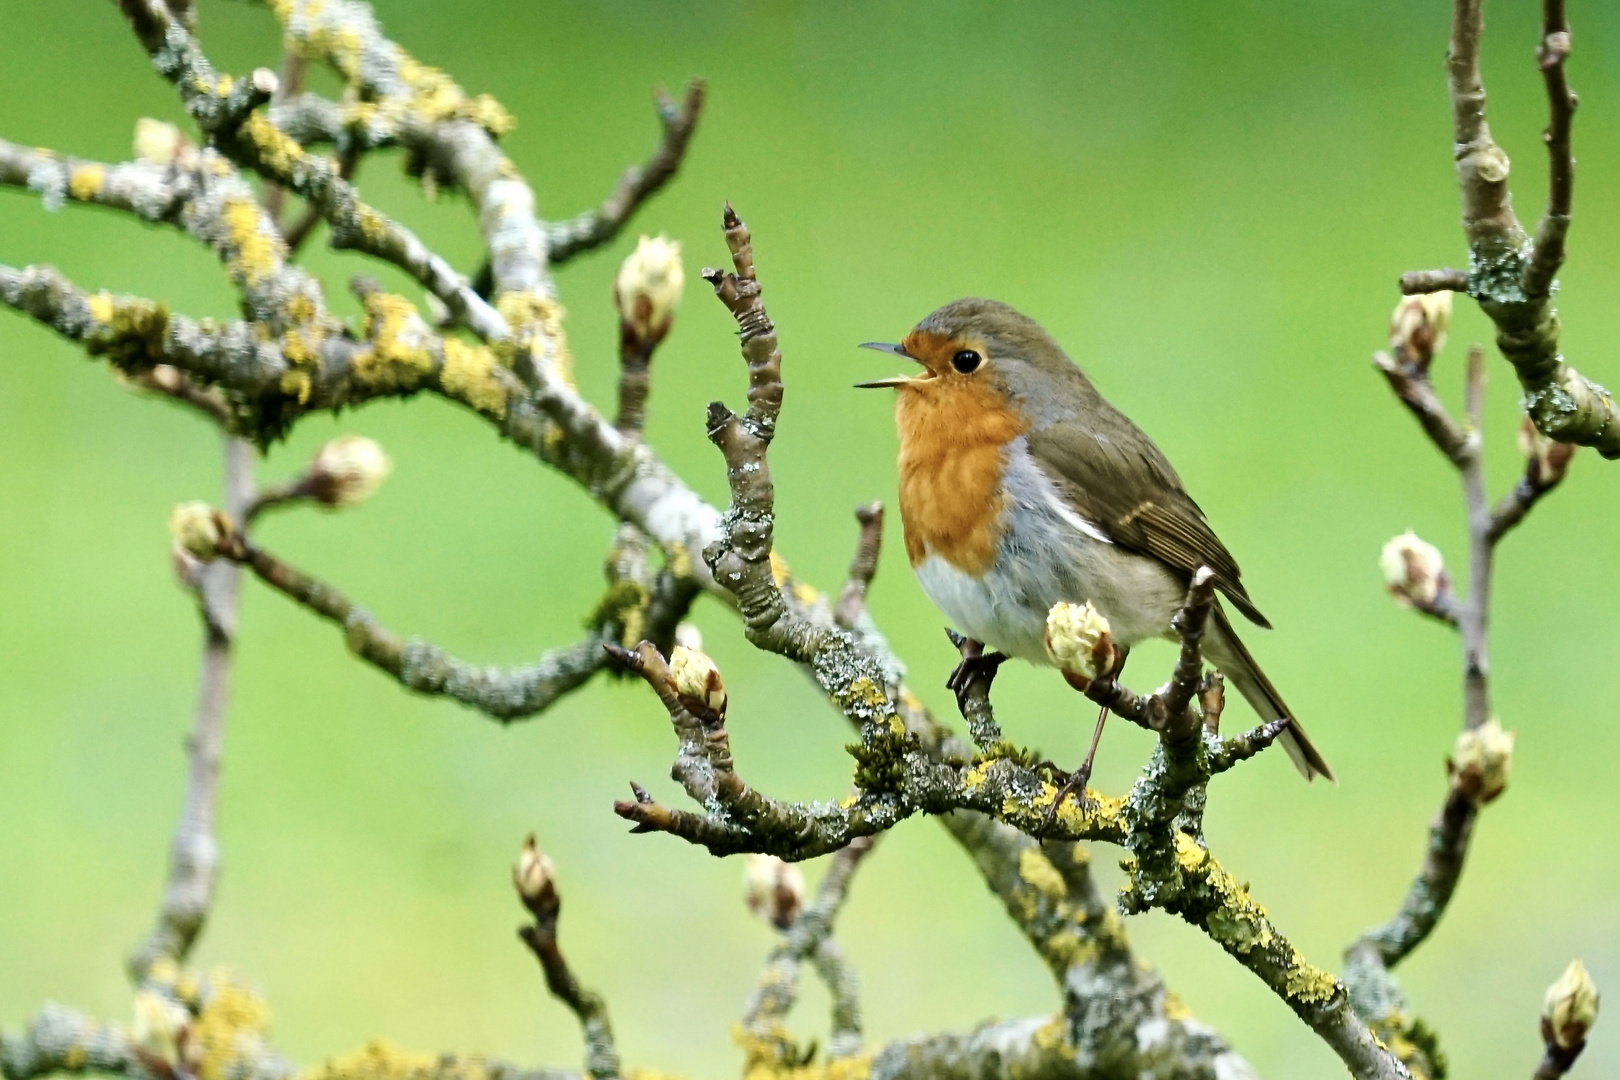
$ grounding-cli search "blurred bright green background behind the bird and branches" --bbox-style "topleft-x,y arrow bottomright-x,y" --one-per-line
0,0 -> 1620,1077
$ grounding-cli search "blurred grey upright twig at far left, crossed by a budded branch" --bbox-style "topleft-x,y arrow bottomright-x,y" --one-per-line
130,436 -> 254,983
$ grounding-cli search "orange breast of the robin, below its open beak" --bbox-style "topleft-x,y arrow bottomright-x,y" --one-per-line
894,379 -> 1027,575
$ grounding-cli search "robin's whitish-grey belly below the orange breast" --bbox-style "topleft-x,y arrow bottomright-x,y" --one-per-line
917,439 -> 1186,664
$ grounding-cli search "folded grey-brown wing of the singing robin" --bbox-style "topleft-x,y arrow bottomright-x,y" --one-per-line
1029,417 -> 1270,627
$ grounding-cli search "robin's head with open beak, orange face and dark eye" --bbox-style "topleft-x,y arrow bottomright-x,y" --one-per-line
855,298 -> 1095,426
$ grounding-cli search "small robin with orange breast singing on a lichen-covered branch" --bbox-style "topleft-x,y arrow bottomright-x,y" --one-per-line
857,298 -> 1337,790
